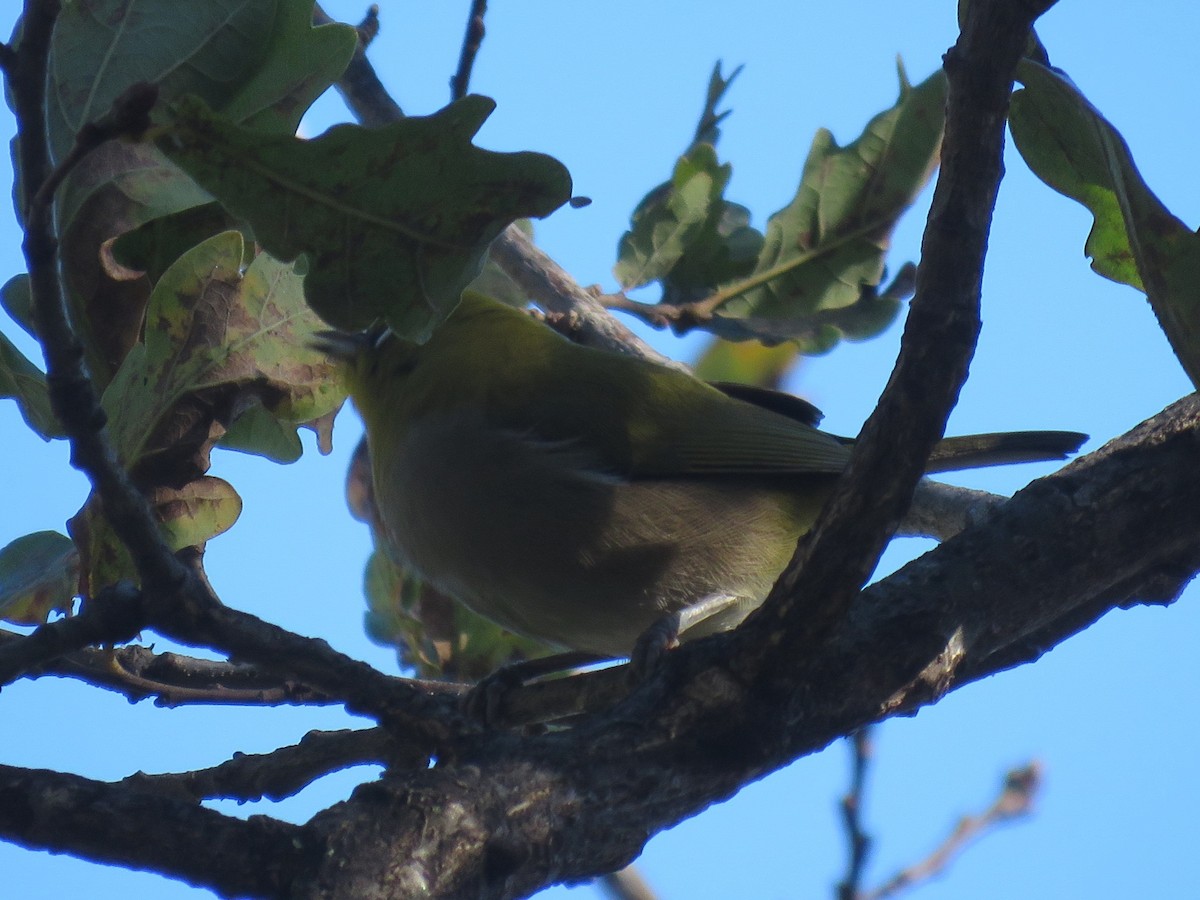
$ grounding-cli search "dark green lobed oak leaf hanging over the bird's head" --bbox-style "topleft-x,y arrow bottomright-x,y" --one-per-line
157,96 -> 571,341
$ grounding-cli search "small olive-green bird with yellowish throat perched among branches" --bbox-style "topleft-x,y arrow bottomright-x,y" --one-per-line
322,292 -> 1086,656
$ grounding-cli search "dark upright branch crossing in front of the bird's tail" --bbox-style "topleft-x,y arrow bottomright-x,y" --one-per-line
738,0 -> 1065,676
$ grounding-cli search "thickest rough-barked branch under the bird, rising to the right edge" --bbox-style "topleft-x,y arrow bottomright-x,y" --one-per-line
292,395 -> 1200,898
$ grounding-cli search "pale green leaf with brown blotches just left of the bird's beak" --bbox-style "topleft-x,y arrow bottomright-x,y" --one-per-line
102,232 -> 344,472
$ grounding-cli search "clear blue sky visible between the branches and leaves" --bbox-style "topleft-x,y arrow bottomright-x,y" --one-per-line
0,0 -> 1200,900
